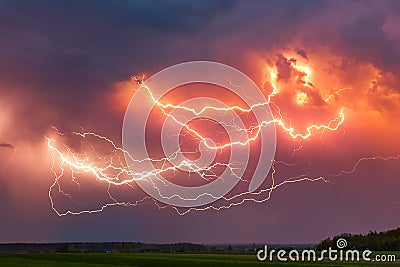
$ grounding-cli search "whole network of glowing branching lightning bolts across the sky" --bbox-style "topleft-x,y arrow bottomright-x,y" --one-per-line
46,57 -> 400,216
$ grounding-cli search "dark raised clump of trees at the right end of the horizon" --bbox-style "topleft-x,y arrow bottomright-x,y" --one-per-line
317,227 -> 400,251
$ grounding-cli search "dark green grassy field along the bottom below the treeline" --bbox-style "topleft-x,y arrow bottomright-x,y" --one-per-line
0,253 -> 400,267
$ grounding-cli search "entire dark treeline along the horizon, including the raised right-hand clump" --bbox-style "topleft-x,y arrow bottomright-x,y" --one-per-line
0,228 -> 400,253
